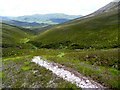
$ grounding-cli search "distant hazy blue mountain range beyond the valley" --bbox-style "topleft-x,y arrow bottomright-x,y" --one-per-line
0,13 -> 81,28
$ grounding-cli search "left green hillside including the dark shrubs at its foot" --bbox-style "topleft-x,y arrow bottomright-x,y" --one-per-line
1,23 -> 33,48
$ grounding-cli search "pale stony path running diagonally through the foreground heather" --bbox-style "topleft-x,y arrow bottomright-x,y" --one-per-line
32,56 -> 105,90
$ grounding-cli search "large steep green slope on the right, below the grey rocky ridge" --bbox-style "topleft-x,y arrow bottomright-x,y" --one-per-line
34,10 -> 118,48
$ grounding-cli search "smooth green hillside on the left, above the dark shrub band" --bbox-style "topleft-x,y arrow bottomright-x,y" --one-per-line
2,23 -> 31,44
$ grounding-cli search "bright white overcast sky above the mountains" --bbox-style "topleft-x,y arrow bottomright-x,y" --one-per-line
0,0 -> 113,16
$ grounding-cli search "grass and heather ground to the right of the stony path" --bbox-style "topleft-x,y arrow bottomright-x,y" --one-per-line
39,49 -> 120,88
